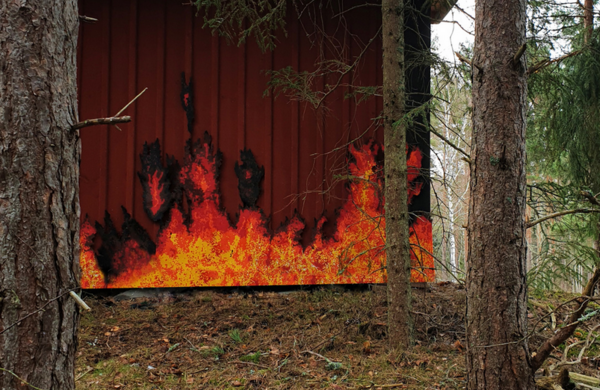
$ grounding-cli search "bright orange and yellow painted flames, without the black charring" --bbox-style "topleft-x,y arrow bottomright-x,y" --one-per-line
80,142 -> 434,288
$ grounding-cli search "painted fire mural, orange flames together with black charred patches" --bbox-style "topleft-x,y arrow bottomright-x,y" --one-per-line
80,78 -> 434,288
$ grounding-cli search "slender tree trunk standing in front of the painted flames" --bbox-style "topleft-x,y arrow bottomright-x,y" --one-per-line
381,0 -> 412,348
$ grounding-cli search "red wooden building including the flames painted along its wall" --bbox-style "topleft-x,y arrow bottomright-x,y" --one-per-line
78,0 -> 433,288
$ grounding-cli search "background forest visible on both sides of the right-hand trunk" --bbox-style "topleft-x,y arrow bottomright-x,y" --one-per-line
431,1 -> 600,292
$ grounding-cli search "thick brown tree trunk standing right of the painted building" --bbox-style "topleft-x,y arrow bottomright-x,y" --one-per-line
467,0 -> 535,390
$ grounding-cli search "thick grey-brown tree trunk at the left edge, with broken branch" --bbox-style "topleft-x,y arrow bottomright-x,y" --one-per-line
0,0 -> 80,390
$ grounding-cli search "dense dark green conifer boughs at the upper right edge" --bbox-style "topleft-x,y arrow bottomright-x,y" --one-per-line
528,32 -> 600,187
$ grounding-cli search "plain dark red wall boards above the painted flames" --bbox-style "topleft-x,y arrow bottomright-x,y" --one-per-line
78,0 -> 382,239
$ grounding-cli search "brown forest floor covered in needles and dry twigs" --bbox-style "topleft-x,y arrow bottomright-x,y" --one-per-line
76,283 -> 600,390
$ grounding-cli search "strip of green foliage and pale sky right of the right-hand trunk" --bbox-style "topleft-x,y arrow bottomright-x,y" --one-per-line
527,0 -> 600,288
